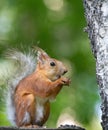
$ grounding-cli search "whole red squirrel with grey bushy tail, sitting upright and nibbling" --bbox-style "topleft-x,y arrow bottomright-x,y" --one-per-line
3,47 -> 70,128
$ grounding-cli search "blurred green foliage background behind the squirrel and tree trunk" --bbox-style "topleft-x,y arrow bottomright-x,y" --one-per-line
0,0 -> 100,130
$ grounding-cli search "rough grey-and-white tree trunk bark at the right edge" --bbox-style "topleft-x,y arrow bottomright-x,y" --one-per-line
83,0 -> 108,130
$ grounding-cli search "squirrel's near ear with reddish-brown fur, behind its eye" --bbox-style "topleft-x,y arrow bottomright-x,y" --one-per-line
37,51 -> 49,64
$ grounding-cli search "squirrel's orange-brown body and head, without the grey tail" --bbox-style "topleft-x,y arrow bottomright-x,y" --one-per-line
14,47 -> 69,127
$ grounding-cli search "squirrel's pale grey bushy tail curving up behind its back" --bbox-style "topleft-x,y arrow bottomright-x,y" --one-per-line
6,49 -> 36,125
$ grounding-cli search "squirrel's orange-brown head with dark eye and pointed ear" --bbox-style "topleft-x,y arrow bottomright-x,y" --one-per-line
37,49 -> 68,81
